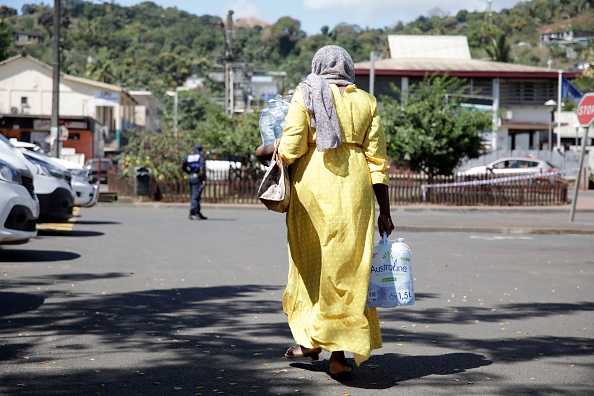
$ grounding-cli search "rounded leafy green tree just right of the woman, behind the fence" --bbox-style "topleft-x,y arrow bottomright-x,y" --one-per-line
382,75 -> 492,182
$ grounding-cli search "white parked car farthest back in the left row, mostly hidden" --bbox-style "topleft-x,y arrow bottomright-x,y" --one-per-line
10,139 -> 99,208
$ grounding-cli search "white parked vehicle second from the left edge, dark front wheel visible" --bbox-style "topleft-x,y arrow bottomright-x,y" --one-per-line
23,151 -> 76,223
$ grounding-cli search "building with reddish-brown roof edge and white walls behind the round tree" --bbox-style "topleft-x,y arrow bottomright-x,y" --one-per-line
355,35 -> 580,150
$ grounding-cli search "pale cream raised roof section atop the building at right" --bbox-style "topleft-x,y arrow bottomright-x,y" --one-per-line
388,35 -> 471,59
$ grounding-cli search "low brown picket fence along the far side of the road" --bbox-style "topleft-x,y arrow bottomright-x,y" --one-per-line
108,167 -> 568,206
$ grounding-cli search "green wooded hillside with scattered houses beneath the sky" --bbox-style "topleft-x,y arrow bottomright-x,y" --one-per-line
0,0 -> 594,94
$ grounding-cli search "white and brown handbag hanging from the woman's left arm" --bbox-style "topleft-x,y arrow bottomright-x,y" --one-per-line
258,143 -> 291,213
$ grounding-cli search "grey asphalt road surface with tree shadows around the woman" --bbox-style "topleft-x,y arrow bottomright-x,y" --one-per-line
0,205 -> 594,396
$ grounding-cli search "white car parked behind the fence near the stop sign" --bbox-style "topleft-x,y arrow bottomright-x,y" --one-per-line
459,157 -> 558,176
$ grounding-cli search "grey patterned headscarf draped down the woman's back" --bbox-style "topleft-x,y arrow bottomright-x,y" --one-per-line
299,45 -> 355,151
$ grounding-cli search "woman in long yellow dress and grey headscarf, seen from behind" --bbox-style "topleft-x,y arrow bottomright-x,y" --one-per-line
256,45 -> 394,380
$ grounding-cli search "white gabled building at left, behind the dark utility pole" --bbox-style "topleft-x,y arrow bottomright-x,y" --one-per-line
0,55 -> 136,158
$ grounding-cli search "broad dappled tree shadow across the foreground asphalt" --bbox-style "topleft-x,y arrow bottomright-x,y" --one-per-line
0,284 -> 594,396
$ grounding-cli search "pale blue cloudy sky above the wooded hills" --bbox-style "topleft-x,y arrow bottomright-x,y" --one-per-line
3,0 -> 520,35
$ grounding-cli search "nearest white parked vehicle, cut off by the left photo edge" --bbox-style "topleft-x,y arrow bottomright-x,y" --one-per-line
0,134 -> 39,245
